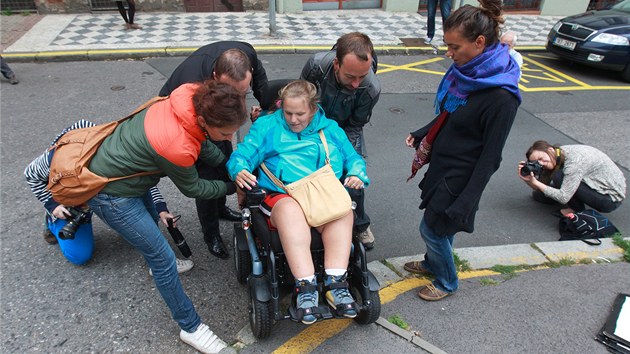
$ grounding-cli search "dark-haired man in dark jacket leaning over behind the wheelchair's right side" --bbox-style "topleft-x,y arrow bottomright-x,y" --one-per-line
300,32 -> 381,249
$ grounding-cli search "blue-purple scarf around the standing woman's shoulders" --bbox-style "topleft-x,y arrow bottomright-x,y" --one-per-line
435,43 -> 521,114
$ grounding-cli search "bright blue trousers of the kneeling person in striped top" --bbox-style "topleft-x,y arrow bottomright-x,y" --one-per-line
46,216 -> 94,265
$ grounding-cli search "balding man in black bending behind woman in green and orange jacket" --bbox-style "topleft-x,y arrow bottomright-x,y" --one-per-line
160,41 -> 267,259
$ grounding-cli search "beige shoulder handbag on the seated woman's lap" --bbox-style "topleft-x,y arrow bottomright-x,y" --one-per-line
260,130 -> 352,227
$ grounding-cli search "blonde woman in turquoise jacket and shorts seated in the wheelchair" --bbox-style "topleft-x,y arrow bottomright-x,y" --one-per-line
227,81 -> 369,324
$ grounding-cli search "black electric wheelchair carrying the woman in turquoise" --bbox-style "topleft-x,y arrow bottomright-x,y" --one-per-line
233,187 -> 381,338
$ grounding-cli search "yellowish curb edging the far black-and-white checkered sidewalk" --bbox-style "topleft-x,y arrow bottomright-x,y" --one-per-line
2,45 -> 545,63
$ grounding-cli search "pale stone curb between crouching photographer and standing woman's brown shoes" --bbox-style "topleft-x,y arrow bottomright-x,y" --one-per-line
368,237 -> 630,288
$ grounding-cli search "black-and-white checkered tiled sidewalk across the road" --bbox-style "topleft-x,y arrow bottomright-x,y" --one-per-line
6,10 -> 559,53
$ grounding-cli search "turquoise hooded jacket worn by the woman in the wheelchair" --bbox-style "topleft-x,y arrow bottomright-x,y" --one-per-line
226,107 -> 370,193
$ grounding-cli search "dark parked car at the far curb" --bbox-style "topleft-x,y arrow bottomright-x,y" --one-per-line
546,0 -> 630,81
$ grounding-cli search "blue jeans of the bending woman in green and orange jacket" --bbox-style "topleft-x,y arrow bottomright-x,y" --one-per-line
88,193 -> 201,332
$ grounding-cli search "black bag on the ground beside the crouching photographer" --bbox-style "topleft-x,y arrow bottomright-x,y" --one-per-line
558,209 -> 619,246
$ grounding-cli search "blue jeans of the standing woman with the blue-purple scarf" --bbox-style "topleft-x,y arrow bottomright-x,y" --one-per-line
420,218 -> 458,293
